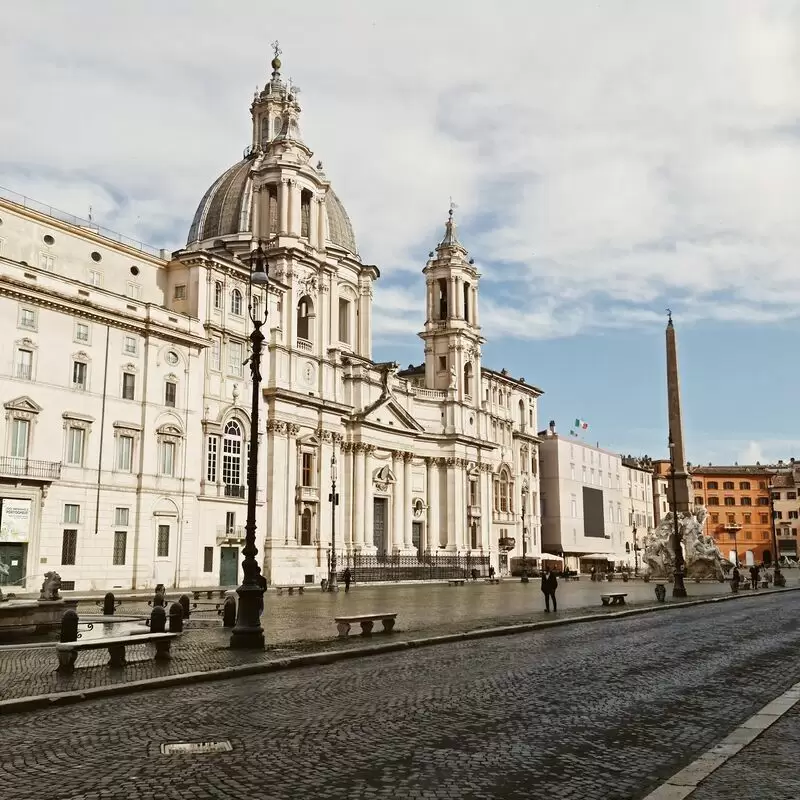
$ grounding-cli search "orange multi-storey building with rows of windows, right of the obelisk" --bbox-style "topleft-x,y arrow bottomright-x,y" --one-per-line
689,464 -> 774,564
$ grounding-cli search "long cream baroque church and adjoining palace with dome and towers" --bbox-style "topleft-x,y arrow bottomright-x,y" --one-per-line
0,53 -> 541,589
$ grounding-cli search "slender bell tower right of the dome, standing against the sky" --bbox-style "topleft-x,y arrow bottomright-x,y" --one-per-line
419,208 -> 484,407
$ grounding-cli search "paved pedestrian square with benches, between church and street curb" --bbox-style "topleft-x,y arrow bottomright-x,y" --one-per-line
0,582 -> 752,700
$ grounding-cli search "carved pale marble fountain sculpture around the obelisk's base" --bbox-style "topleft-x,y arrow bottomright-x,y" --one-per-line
644,507 -> 725,581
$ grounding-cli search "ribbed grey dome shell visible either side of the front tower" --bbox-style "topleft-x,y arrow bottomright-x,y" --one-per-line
186,155 -> 358,257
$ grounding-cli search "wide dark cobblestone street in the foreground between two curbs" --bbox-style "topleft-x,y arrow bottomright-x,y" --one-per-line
0,592 -> 800,800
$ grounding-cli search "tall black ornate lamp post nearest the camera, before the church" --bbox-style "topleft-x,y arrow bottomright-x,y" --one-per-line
231,242 -> 269,650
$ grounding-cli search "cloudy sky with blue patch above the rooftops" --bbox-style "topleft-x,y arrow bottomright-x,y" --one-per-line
0,0 -> 800,463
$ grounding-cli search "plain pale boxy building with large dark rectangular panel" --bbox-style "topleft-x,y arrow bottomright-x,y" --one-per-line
539,422 -> 633,571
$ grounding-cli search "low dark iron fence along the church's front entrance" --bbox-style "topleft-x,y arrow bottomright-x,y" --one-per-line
337,553 -> 489,583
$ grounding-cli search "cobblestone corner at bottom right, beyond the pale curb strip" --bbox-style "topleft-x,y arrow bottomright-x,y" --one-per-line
690,704 -> 800,800
